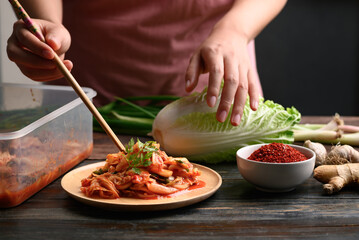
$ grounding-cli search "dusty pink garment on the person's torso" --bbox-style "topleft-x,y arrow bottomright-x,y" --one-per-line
55,0 -> 255,106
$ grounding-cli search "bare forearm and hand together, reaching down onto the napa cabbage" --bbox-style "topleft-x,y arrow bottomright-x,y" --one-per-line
185,0 -> 287,126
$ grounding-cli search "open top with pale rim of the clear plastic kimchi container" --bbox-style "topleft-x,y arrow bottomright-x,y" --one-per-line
0,83 -> 96,140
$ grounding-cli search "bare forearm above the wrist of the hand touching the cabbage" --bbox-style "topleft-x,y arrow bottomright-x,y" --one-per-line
213,0 -> 287,42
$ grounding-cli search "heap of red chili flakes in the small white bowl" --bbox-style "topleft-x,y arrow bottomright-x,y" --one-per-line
248,143 -> 308,163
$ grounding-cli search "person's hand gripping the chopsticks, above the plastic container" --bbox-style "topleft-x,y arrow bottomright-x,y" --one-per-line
7,19 -> 73,82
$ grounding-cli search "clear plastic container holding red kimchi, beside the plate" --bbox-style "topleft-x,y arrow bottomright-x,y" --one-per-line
0,84 -> 96,208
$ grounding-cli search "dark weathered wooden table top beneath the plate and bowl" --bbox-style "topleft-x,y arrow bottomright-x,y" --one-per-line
0,117 -> 359,240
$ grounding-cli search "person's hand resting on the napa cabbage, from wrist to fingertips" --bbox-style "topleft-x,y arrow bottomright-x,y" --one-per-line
186,27 -> 261,126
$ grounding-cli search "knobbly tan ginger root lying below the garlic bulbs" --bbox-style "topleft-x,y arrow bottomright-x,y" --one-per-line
313,163 -> 359,195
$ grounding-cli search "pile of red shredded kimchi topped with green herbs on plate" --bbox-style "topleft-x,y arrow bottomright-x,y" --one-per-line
81,139 -> 201,199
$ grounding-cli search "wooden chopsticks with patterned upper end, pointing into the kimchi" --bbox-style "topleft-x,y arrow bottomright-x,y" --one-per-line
9,0 -> 126,152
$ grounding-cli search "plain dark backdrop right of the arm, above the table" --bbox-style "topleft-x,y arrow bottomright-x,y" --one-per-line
256,0 -> 359,115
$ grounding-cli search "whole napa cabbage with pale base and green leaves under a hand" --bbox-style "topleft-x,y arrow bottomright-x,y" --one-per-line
151,89 -> 301,163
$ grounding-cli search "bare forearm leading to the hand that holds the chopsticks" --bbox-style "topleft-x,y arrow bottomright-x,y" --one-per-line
19,0 -> 62,23
